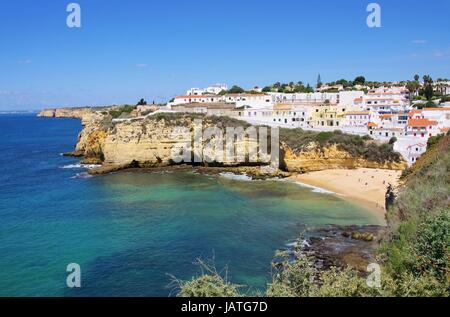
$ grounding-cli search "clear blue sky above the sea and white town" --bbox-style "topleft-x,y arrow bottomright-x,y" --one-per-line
0,0 -> 450,110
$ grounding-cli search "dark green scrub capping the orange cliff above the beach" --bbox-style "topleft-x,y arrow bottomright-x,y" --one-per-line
280,129 -> 401,163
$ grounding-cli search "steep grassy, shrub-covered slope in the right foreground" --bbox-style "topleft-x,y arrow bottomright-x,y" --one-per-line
381,134 -> 450,291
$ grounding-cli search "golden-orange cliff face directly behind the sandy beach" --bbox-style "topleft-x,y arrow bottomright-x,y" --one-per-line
282,143 -> 406,173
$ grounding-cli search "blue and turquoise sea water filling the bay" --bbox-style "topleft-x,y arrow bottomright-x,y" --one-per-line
0,116 -> 377,296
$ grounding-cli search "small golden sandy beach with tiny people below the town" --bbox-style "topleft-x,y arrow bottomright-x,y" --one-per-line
290,168 -> 401,221
